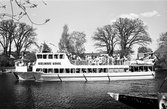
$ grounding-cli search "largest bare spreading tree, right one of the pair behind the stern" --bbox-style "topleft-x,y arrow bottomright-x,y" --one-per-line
113,18 -> 152,57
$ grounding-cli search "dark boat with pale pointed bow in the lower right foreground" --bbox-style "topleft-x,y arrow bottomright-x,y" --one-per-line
108,92 -> 159,109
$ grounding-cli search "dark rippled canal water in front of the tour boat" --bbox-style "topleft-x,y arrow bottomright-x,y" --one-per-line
0,71 -> 167,109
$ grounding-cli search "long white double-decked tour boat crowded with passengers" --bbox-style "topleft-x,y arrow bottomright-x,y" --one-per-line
13,53 -> 155,81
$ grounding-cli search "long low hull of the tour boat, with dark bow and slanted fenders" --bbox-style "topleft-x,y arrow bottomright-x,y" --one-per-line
14,71 -> 155,81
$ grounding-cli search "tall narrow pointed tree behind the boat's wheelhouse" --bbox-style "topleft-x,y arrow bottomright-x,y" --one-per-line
58,25 -> 73,53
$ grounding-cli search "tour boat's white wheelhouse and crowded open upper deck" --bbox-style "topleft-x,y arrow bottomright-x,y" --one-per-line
36,53 -> 153,66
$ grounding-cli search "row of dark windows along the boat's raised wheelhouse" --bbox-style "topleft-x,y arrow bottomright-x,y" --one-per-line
37,54 -> 64,59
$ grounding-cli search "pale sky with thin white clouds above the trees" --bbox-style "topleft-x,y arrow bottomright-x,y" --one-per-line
0,0 -> 167,58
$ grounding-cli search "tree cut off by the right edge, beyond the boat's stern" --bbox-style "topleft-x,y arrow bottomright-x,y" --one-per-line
155,32 -> 167,68
